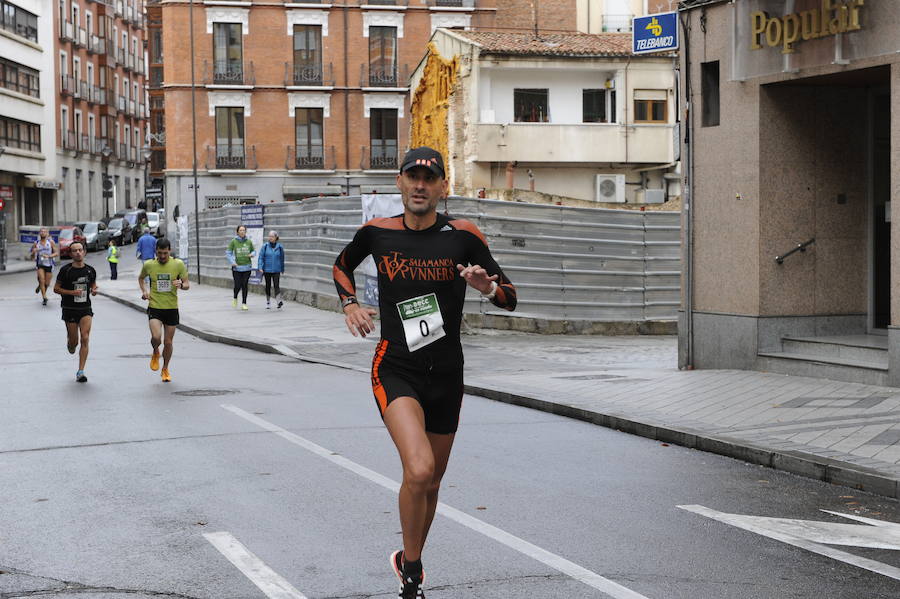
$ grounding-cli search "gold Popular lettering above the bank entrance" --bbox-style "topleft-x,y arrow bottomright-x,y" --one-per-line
750,0 -> 866,54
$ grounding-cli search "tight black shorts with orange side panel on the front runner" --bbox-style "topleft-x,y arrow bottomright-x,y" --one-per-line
372,339 -> 463,435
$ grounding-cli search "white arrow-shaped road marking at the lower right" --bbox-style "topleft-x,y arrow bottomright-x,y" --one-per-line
678,505 -> 900,580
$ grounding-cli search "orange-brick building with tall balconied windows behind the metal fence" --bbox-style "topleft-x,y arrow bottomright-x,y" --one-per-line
158,0 -> 496,220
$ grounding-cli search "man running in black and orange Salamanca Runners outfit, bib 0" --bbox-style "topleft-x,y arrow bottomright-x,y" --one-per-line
334,147 -> 516,599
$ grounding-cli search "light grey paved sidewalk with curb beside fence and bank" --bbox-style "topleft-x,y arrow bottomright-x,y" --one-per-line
98,269 -> 900,498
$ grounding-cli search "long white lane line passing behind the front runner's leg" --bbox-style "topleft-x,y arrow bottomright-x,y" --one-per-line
222,404 -> 648,599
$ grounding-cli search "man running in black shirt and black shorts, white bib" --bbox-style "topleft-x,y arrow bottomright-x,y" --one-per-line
53,241 -> 97,383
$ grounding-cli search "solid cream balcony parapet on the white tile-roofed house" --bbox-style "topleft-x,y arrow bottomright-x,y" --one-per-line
476,123 -> 674,164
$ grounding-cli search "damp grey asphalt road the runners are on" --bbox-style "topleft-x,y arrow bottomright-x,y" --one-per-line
0,264 -> 900,599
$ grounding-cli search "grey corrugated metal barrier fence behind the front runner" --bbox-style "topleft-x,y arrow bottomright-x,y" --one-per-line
189,196 -> 681,322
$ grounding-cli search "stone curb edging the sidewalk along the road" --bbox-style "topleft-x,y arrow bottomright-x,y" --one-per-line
99,291 -> 900,499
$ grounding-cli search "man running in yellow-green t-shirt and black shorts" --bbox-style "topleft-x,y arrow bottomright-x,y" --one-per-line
138,237 -> 191,383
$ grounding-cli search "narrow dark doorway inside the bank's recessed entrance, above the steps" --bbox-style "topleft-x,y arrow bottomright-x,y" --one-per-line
870,89 -> 891,329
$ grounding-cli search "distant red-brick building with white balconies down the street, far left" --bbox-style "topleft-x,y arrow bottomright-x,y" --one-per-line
55,0 -> 147,224
